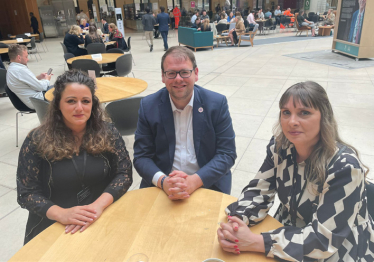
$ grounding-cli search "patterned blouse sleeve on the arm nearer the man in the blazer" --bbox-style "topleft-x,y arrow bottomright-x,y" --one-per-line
226,137 -> 276,226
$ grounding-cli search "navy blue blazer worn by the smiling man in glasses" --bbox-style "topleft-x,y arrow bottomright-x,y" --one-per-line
134,85 -> 236,194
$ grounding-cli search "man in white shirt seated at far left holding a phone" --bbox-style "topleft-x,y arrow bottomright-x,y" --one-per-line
6,44 -> 51,109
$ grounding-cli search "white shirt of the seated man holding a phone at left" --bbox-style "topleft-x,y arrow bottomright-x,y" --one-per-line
6,62 -> 49,109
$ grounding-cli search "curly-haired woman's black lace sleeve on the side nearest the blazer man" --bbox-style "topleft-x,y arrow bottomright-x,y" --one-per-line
104,125 -> 132,201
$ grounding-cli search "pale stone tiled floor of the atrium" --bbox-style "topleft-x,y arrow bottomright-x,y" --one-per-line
0,29 -> 374,261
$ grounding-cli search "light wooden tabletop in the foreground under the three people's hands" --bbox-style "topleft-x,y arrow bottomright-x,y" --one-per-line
9,187 -> 282,262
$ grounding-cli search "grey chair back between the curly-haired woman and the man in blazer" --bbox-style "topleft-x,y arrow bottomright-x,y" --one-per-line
105,97 -> 143,136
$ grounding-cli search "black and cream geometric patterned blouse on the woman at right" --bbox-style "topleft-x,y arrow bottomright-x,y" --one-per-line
226,138 -> 374,262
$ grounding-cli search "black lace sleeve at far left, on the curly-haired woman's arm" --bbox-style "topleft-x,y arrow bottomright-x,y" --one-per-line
17,133 -> 54,217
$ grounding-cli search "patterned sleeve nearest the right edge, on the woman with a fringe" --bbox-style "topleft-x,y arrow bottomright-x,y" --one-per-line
262,154 -> 364,261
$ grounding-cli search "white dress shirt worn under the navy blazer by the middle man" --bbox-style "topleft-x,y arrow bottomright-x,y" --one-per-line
152,93 -> 200,186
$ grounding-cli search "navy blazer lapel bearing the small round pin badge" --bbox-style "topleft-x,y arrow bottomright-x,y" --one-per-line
192,86 -> 206,159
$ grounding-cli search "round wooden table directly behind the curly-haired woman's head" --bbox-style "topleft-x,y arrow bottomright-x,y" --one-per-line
45,77 -> 148,103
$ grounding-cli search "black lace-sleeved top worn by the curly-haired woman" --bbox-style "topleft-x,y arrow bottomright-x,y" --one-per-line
17,124 -> 132,244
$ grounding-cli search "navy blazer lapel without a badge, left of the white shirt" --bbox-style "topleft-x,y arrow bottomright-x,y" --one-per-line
158,90 -> 176,166
